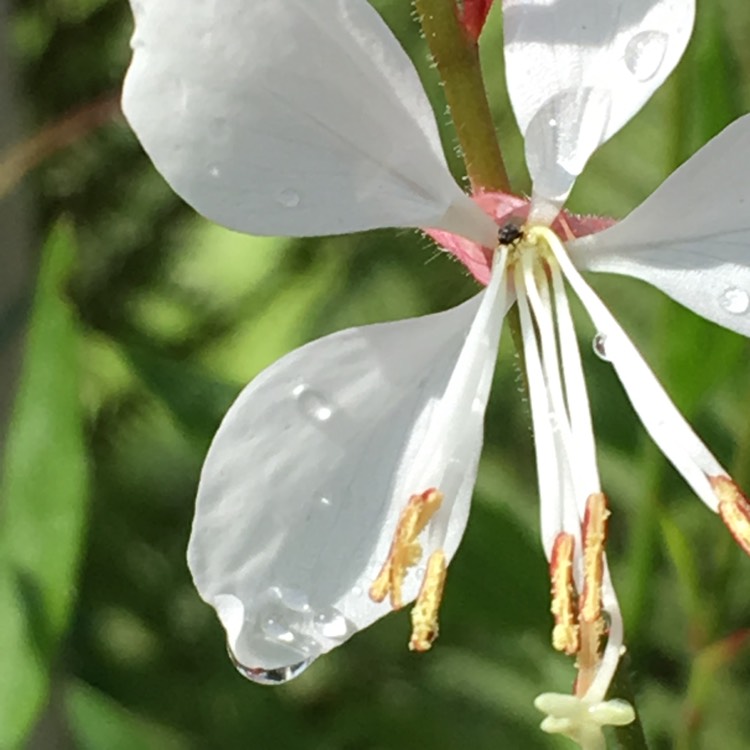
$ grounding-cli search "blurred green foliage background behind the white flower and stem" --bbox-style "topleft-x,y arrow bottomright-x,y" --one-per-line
0,0 -> 750,750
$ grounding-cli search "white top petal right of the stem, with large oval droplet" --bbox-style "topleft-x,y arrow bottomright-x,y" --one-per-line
503,0 -> 695,209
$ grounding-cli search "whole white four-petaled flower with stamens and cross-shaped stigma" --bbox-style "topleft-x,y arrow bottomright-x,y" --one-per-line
123,0 -> 750,748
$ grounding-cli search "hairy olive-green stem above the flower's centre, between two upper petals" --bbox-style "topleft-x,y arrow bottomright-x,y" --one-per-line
414,0 -> 510,192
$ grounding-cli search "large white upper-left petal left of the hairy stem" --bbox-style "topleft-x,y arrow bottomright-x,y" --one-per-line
123,0 -> 496,246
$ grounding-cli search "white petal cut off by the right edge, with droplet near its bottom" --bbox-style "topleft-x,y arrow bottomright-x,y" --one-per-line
568,115 -> 750,336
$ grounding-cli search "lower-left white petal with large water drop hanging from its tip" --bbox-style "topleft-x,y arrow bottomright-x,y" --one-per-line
188,262 -> 507,669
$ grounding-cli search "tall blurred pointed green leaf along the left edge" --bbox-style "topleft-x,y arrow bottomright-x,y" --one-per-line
0,220 -> 88,750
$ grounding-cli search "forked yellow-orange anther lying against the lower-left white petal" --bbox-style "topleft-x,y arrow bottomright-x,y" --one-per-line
370,489 -> 443,609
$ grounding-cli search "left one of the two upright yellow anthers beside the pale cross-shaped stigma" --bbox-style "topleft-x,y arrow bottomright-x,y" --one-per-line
549,533 -> 580,656
